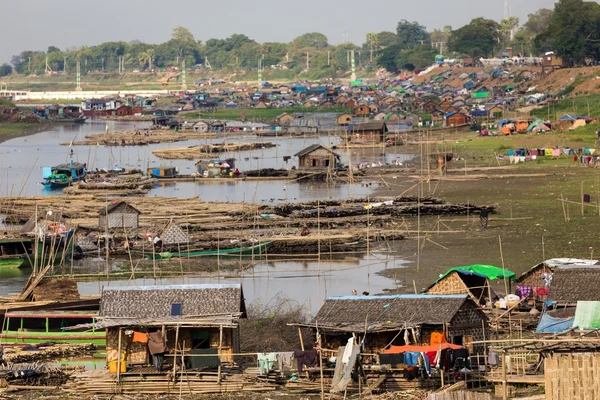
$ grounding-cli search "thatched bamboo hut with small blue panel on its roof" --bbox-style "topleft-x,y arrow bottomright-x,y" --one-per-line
101,284 -> 246,368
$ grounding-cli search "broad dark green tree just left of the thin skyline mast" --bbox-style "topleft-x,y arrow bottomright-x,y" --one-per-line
448,18 -> 500,57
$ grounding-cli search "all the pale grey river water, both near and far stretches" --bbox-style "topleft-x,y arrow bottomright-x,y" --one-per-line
0,120 -> 411,313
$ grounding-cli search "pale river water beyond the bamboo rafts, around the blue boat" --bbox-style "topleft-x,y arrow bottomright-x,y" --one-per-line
0,120 -> 411,202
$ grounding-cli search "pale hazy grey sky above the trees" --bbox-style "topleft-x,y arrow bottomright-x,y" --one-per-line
0,0 -> 554,63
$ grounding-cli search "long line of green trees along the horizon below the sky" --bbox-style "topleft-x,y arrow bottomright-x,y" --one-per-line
0,0 -> 600,77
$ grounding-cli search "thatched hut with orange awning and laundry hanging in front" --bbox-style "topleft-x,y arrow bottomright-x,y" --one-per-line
300,295 -> 488,353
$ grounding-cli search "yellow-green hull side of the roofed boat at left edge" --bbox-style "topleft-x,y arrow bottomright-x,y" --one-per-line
0,331 -> 106,346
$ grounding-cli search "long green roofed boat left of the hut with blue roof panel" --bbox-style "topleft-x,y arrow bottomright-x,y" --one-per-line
0,310 -> 106,345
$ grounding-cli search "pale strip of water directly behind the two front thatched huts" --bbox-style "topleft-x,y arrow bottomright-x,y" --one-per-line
79,254 -> 407,312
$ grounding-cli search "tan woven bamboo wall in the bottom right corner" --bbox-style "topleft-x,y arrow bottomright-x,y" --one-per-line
544,353 -> 600,400
